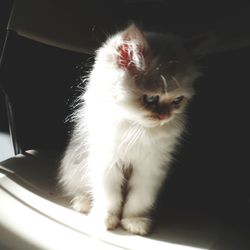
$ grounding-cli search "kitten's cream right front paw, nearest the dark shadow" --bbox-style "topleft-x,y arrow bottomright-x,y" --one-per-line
121,217 -> 152,235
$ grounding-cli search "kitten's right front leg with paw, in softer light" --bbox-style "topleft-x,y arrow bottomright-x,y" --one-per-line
121,166 -> 166,235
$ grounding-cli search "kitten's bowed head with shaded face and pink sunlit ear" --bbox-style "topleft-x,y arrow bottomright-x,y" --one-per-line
95,24 -> 199,127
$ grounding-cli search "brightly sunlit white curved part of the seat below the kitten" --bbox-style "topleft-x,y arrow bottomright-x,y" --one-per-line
0,173 -> 206,250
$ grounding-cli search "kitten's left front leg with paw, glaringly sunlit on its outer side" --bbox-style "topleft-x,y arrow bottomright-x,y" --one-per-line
90,162 -> 124,230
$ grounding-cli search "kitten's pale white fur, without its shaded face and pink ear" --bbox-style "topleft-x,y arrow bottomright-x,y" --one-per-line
59,26 -> 197,235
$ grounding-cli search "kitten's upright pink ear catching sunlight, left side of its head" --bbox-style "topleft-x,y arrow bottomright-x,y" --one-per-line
117,24 -> 148,74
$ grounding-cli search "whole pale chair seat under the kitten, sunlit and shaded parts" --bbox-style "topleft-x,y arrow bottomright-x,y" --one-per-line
0,150 -> 221,250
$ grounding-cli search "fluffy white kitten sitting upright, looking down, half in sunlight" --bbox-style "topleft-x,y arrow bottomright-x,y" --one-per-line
59,24 -> 199,235
